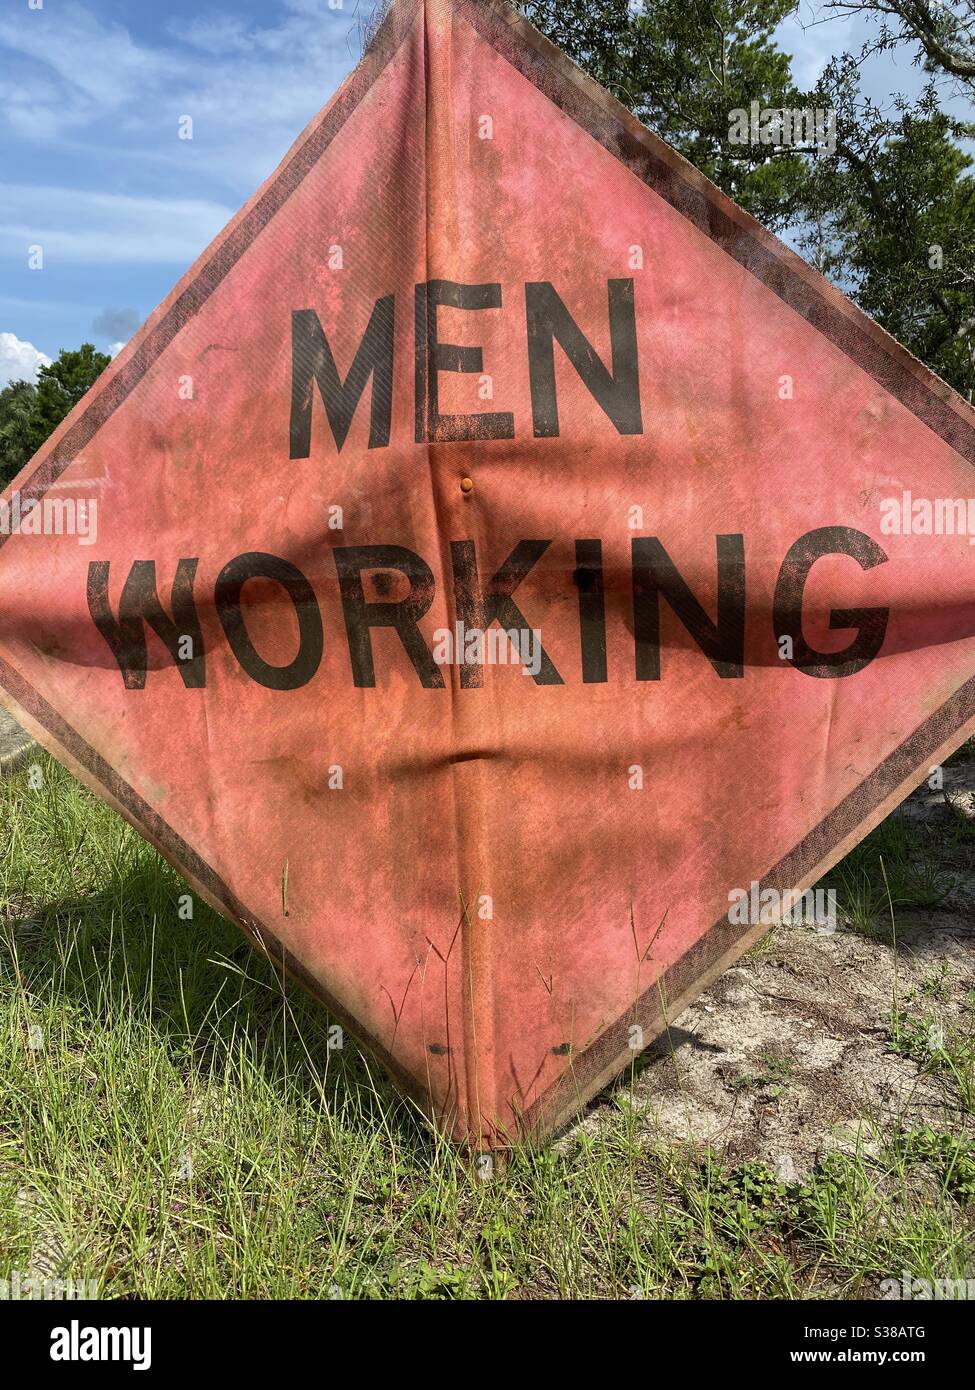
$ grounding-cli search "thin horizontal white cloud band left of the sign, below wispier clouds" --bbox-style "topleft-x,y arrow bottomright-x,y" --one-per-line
0,183 -> 232,265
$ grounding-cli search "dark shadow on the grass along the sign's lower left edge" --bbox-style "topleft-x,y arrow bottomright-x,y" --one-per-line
0,835 -> 437,1151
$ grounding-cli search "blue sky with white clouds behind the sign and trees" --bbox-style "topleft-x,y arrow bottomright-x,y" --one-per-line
0,0 -> 968,385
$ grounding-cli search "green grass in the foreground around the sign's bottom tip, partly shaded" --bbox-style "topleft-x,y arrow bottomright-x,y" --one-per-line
0,759 -> 975,1300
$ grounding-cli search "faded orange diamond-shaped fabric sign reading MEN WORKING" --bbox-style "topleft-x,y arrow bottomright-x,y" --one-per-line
0,0 -> 975,1148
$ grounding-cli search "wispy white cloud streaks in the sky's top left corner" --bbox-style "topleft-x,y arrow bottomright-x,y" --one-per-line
0,0 -> 371,192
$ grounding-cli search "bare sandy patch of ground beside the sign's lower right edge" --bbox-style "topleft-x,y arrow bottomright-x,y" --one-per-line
570,762 -> 975,1182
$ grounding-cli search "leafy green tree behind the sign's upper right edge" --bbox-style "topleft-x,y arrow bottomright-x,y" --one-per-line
522,0 -> 975,400
